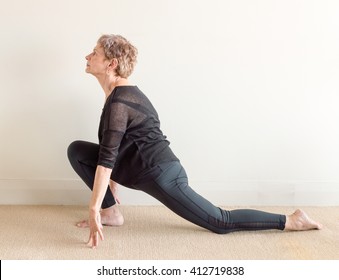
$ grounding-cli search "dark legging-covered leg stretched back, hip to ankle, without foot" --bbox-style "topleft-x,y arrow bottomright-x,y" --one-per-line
135,163 -> 322,233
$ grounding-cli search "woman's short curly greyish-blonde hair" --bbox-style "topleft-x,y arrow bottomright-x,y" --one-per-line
98,34 -> 138,78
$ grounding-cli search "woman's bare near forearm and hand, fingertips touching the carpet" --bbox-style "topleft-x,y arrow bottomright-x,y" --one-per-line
87,165 -> 112,249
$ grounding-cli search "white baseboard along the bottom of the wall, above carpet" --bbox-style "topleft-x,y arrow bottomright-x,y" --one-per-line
0,179 -> 339,206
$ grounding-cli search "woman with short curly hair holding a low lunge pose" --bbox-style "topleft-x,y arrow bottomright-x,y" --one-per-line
68,35 -> 322,248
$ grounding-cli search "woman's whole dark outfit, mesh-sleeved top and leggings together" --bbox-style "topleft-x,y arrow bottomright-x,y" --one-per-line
68,86 -> 286,233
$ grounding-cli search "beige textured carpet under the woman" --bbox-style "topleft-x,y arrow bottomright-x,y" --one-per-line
0,205 -> 339,260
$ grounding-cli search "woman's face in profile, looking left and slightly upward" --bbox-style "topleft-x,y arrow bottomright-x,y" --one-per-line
86,44 -> 109,76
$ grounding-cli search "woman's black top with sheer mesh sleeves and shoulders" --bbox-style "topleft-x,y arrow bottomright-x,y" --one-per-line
98,86 -> 178,185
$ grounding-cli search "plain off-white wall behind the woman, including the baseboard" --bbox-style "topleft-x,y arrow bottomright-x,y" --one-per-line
0,0 -> 339,205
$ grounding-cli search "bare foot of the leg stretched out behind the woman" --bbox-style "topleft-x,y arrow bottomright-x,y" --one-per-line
285,209 -> 323,231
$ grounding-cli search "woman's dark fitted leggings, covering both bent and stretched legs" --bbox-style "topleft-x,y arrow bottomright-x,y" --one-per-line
68,141 -> 286,234
